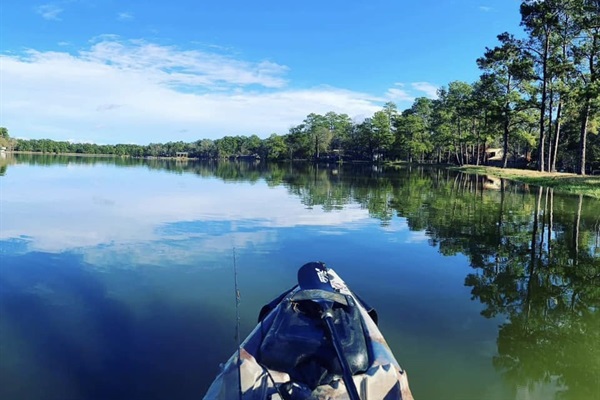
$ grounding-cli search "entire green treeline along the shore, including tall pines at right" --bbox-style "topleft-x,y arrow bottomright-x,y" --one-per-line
0,0 -> 600,174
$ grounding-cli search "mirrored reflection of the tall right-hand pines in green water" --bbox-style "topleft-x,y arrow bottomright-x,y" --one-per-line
465,188 -> 600,399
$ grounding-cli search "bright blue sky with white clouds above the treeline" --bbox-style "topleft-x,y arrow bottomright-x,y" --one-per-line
0,0 -> 521,144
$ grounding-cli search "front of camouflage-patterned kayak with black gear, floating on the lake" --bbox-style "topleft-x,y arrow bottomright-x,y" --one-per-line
204,262 -> 413,400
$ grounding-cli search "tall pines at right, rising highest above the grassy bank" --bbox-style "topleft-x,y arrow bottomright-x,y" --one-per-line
472,0 -> 600,174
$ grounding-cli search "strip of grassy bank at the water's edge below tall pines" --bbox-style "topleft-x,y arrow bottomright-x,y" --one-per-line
453,165 -> 600,199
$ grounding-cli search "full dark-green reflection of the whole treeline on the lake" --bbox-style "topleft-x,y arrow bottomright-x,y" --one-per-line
2,155 -> 600,399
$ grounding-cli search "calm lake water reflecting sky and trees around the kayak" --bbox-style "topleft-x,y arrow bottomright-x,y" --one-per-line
0,156 -> 600,400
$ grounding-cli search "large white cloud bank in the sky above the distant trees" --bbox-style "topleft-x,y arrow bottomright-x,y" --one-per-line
0,36 -> 381,144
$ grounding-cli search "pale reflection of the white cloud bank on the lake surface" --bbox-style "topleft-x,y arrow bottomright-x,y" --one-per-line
0,172 -> 371,252
